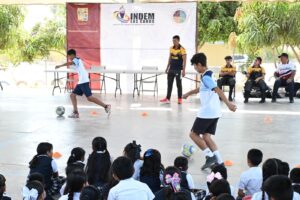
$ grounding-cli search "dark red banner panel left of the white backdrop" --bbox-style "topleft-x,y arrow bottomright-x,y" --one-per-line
67,3 -> 101,89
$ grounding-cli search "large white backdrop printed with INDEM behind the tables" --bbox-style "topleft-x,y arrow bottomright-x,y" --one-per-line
100,2 -> 197,92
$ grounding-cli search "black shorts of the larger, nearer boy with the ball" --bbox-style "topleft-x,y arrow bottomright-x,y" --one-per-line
191,117 -> 219,135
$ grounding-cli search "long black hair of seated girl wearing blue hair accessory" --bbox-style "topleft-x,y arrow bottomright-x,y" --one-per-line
140,149 -> 163,177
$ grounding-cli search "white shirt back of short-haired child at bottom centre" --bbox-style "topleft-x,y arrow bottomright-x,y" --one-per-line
108,178 -> 154,200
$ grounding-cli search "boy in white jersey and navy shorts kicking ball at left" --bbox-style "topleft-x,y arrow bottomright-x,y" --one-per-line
55,49 -> 111,118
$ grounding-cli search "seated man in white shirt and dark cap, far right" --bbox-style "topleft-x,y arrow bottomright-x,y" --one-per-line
272,53 -> 296,103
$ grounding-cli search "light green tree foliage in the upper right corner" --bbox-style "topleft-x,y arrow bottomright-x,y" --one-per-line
237,2 -> 300,62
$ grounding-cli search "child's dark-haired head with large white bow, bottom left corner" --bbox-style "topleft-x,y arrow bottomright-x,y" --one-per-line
22,181 -> 46,200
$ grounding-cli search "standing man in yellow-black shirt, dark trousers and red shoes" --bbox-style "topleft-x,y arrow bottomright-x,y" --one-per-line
160,35 -> 186,104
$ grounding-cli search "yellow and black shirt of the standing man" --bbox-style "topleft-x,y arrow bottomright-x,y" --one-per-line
170,45 -> 186,71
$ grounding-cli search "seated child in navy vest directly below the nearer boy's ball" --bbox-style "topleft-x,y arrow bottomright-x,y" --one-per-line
174,156 -> 195,190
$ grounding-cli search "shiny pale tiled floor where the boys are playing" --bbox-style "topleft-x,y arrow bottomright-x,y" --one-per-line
0,89 -> 300,199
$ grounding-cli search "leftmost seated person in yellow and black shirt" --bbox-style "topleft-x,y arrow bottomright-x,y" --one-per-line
218,56 -> 236,101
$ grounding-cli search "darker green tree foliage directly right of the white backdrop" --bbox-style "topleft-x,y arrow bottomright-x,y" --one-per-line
198,2 -> 240,48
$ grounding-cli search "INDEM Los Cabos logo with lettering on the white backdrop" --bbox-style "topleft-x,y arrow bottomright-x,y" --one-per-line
113,6 -> 155,25
